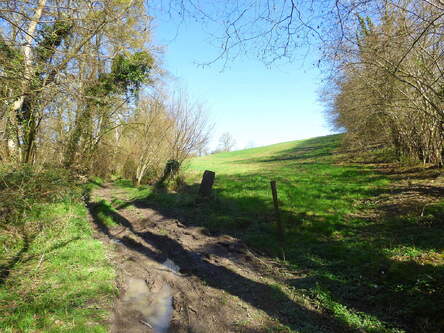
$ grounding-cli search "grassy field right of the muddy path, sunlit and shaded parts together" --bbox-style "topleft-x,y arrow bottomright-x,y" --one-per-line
125,135 -> 444,332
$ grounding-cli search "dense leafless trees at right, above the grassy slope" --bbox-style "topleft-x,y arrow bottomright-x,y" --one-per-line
322,0 -> 444,165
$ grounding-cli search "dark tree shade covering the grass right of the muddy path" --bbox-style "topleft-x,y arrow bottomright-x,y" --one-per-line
128,186 -> 444,333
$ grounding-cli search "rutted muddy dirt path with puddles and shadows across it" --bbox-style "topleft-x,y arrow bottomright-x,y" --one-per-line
89,185 -> 338,333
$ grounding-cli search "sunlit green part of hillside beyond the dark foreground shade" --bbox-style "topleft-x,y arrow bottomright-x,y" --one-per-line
188,135 -> 389,246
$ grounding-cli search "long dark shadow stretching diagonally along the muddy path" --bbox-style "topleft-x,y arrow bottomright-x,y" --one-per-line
88,203 -> 353,332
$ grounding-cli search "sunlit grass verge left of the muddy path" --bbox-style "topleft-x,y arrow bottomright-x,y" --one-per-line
0,174 -> 117,333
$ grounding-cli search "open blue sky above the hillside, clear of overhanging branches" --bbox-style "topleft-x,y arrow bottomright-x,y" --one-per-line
153,13 -> 331,149
